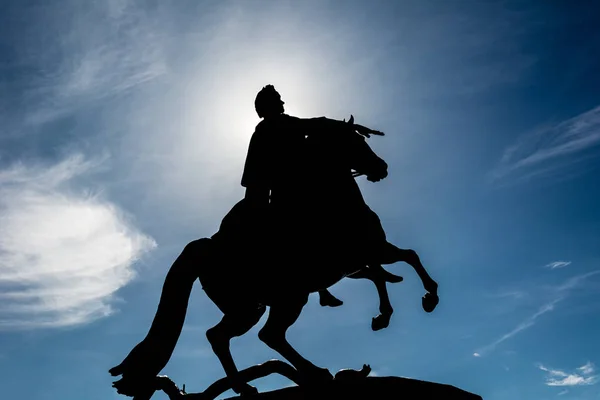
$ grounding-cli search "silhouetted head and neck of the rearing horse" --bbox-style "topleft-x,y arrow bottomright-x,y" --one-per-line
308,117 -> 388,182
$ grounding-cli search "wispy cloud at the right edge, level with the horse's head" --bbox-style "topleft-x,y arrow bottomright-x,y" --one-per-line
490,106 -> 600,182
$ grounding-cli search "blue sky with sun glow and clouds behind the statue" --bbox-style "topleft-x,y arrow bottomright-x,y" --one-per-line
0,0 -> 600,400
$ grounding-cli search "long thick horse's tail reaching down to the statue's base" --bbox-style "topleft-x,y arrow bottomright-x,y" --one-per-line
109,238 -> 211,388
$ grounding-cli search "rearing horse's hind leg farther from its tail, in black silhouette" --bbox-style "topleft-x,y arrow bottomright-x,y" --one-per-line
258,295 -> 333,383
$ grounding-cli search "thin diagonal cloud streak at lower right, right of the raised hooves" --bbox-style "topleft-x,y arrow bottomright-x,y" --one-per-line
473,270 -> 600,357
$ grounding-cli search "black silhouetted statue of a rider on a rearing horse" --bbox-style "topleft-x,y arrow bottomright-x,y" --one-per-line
110,86 -> 439,400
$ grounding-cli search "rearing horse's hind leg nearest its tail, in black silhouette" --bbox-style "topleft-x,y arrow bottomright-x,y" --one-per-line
206,306 -> 265,395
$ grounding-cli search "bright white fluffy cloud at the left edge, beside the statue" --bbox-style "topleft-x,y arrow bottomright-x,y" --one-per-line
0,156 -> 156,330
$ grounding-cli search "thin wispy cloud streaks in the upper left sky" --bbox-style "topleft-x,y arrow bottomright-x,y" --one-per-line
24,0 -> 167,125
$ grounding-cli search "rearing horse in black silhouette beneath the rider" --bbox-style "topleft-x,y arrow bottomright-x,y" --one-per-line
110,119 -> 437,400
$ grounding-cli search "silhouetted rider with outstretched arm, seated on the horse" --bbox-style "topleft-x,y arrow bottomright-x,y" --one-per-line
241,85 -> 381,306
